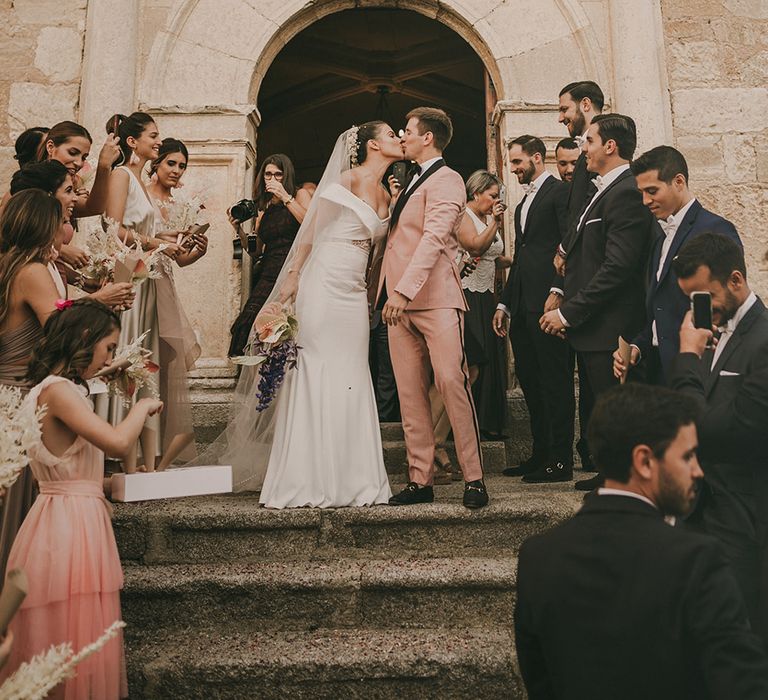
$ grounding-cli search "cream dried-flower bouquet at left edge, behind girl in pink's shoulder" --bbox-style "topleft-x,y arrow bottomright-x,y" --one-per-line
0,384 -> 45,489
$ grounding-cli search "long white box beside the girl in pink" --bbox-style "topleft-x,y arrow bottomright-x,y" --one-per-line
112,466 -> 232,502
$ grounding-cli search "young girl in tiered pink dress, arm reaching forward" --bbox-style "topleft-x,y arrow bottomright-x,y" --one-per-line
3,299 -> 163,700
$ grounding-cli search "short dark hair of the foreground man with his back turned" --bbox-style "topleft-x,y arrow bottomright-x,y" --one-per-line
587,383 -> 699,484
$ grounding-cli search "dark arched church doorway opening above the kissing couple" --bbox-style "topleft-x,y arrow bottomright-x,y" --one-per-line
256,8 -> 488,182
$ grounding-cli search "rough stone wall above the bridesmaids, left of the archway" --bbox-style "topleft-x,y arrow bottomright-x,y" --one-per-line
0,0 -> 87,186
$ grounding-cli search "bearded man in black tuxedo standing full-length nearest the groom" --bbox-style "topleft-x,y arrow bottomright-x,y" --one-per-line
493,134 -> 574,483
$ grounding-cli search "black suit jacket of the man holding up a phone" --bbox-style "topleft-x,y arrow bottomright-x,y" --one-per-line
670,299 -> 768,486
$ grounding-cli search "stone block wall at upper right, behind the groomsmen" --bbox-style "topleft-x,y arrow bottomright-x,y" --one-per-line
662,0 -> 768,288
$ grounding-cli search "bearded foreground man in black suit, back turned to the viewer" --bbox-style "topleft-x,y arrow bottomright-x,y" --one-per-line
515,384 -> 768,700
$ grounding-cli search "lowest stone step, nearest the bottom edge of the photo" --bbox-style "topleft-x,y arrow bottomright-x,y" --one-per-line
127,627 -> 525,700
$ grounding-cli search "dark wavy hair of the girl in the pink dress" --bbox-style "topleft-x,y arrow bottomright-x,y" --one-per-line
27,299 -> 120,386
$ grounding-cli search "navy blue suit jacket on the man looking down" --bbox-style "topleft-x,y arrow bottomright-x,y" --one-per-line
631,201 -> 743,384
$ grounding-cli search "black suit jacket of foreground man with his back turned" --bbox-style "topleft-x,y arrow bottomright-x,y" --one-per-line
515,495 -> 768,700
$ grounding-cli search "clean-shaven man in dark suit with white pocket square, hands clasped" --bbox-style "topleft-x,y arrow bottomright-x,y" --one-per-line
540,114 -> 654,490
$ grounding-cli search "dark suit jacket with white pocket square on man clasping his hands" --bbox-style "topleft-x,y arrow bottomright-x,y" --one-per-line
560,170 -> 655,351
